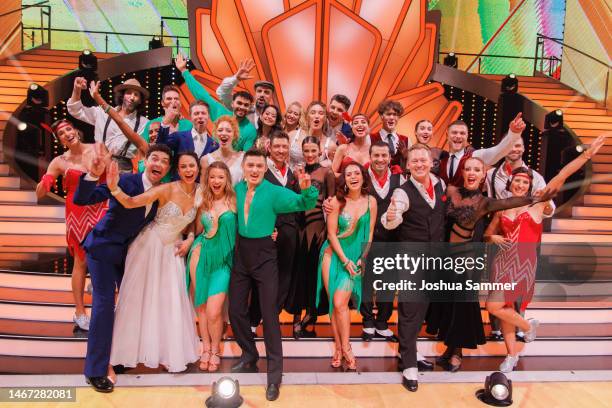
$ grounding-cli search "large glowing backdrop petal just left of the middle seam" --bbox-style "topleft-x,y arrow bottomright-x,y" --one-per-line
262,1 -> 321,110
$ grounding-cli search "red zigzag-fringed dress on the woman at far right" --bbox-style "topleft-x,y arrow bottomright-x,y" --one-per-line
491,211 -> 542,310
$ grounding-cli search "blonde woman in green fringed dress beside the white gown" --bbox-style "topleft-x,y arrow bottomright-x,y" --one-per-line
187,161 -> 236,372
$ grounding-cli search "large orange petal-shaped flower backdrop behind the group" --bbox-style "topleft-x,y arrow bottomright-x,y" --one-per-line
183,0 -> 461,147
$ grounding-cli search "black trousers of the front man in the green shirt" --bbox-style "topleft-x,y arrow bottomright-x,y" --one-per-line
229,235 -> 283,384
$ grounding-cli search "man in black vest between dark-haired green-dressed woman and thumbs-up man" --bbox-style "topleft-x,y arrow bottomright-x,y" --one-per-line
359,140 -> 402,343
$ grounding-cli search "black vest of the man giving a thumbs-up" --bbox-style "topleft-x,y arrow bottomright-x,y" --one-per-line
397,180 -> 445,242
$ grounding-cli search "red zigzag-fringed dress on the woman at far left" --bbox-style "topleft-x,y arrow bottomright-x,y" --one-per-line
64,169 -> 108,259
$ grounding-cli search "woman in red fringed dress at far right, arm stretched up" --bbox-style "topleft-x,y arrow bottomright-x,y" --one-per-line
485,136 -> 605,372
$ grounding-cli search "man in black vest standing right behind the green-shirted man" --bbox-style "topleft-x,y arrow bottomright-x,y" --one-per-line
249,131 -> 301,331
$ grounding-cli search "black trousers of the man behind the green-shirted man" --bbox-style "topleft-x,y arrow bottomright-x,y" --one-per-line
249,224 -> 297,327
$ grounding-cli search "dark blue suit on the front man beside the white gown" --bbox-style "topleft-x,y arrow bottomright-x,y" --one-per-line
73,174 -> 158,377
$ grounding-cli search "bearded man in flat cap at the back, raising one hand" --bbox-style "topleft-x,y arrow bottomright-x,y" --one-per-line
217,59 -> 275,129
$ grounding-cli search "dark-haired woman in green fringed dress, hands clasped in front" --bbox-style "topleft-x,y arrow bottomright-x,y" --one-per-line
317,162 -> 377,371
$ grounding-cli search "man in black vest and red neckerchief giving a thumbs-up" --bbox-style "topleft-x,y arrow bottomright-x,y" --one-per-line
380,143 -> 446,391
